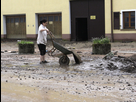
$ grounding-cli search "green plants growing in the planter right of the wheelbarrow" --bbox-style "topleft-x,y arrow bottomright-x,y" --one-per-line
92,37 -> 110,44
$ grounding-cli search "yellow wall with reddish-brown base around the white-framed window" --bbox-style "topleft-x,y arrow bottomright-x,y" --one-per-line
105,0 -> 136,41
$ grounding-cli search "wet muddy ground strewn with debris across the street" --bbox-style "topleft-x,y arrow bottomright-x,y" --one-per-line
1,41 -> 136,102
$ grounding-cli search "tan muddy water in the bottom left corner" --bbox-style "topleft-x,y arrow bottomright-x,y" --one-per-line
1,82 -> 48,102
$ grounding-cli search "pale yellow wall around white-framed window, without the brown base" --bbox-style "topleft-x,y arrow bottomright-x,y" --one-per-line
105,0 -> 136,34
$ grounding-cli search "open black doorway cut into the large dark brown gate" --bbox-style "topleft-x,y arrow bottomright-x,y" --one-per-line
76,18 -> 88,41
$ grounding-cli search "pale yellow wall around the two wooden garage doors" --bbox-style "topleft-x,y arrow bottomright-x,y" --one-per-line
1,0 -> 70,36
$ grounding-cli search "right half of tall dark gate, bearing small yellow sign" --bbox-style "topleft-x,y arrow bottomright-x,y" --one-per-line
88,0 -> 105,39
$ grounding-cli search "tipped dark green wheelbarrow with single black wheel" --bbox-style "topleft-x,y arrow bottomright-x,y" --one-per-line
48,32 -> 82,65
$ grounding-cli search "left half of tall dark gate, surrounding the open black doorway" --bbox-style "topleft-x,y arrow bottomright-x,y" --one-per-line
70,0 -> 88,41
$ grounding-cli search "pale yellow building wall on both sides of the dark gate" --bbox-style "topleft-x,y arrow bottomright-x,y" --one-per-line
1,0 -> 136,40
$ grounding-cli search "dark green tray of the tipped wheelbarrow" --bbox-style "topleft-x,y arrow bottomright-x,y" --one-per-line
53,41 -> 73,55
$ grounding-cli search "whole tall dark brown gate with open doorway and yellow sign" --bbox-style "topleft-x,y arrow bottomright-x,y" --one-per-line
70,0 -> 105,41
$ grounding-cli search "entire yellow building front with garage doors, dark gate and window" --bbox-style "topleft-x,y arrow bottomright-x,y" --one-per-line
1,0 -> 136,41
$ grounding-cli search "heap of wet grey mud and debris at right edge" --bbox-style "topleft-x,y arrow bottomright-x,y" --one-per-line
104,53 -> 136,73
